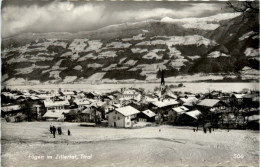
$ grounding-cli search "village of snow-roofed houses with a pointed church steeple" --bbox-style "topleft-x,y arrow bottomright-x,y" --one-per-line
1,71 -> 259,131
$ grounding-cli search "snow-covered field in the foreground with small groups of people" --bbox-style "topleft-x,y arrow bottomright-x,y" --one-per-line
2,122 -> 259,167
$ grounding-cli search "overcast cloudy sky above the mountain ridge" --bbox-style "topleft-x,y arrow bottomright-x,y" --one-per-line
2,0 -> 230,37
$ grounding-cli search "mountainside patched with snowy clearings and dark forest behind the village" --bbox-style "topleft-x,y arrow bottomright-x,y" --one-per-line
2,13 -> 259,84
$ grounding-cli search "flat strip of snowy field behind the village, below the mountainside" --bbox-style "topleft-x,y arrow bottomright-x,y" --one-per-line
6,82 -> 259,93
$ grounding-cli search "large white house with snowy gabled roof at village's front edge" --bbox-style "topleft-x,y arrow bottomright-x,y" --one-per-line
108,106 -> 140,128
